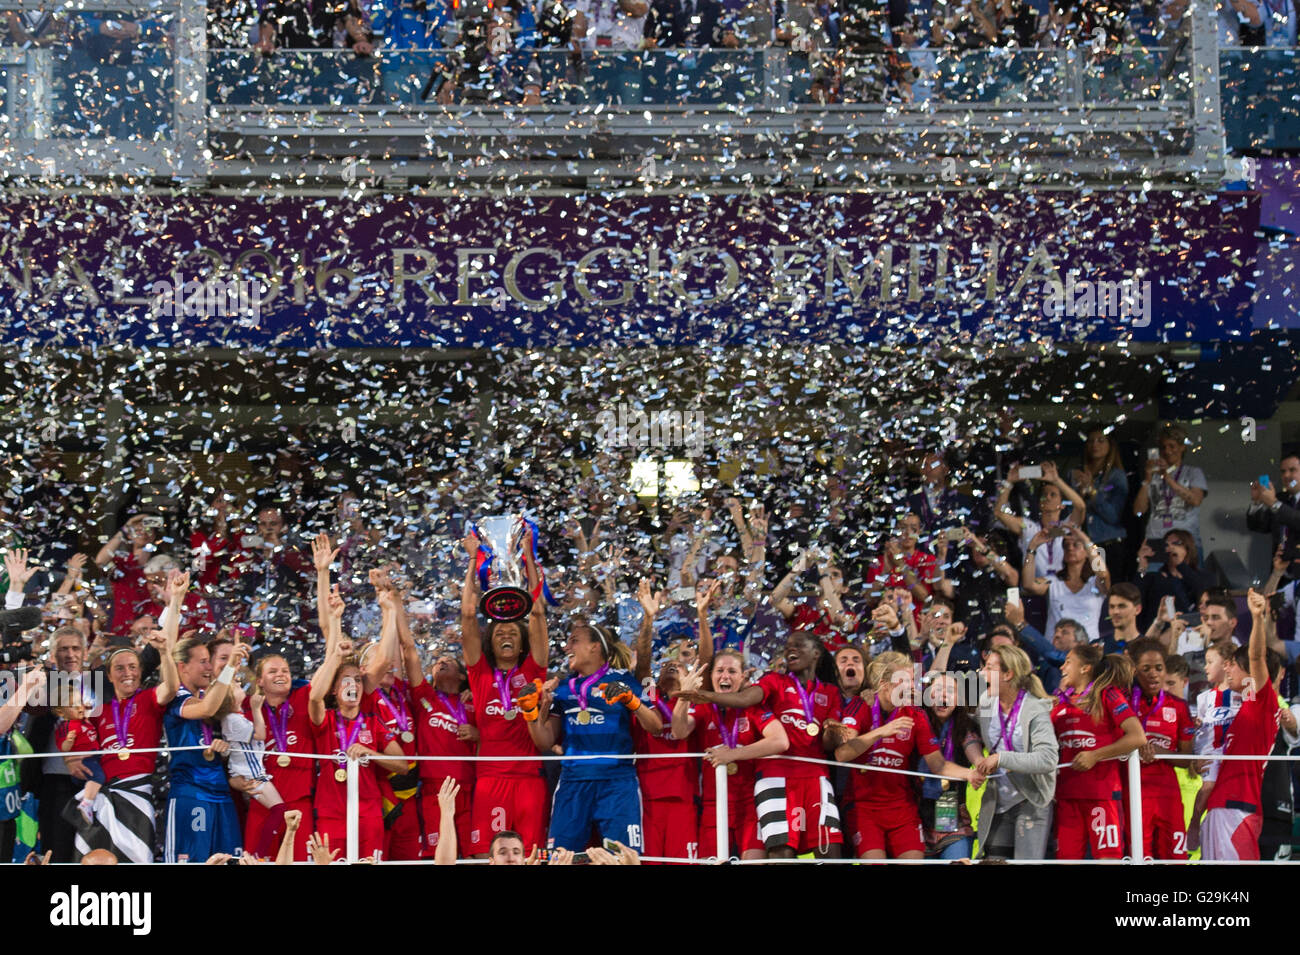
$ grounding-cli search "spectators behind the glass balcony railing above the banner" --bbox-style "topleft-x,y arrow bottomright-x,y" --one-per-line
4,0 -> 1297,108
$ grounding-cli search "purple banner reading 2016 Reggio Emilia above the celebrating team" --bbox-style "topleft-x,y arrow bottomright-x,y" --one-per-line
0,191 -> 1260,348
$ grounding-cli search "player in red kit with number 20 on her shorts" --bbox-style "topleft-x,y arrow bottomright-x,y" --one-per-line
1052,644 -> 1147,859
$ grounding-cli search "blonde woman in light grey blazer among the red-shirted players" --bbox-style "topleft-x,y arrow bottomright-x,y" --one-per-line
971,646 -> 1060,859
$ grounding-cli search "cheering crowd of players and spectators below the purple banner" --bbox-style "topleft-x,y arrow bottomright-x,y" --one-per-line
0,425 -> 1300,863
